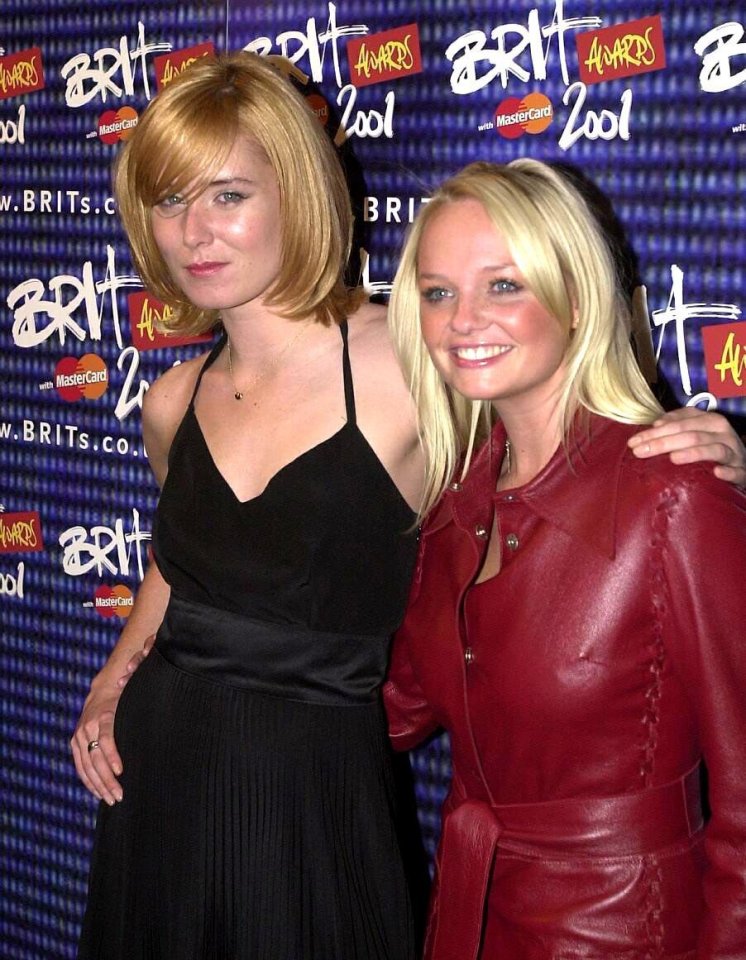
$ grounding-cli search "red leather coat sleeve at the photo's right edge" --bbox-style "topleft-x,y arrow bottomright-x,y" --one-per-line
657,475 -> 746,960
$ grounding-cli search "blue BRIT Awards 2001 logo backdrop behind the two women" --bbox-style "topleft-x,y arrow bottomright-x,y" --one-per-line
0,0 -> 746,960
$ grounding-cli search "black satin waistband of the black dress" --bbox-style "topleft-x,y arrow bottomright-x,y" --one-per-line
155,594 -> 389,706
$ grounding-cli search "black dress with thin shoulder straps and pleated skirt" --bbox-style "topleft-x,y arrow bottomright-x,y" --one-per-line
79,324 -> 424,960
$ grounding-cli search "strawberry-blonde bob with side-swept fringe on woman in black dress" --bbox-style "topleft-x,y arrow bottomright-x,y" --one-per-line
114,52 -> 359,334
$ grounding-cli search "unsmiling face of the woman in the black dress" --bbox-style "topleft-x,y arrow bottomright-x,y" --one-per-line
151,137 -> 282,315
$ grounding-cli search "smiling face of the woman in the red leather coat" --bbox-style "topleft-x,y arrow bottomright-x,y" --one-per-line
417,199 -> 569,413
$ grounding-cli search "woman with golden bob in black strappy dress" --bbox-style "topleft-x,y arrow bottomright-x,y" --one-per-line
72,53 -> 430,960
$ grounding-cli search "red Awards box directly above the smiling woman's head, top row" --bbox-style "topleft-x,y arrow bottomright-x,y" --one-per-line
575,14 -> 666,84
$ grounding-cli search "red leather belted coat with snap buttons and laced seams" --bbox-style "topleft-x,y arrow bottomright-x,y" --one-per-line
385,417 -> 746,960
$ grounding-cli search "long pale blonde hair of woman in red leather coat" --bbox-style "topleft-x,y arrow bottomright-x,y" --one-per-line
389,159 -> 660,516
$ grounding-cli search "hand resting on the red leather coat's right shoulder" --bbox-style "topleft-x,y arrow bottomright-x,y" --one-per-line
629,407 -> 746,486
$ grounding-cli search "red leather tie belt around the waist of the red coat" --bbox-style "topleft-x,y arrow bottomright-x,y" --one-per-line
425,765 -> 702,960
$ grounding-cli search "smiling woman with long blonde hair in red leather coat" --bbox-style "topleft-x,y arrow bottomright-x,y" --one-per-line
384,160 -> 746,960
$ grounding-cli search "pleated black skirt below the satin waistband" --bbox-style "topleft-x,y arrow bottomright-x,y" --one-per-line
78,604 -> 414,960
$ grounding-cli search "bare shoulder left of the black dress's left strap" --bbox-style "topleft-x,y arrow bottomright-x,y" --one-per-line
142,353 -> 208,484
